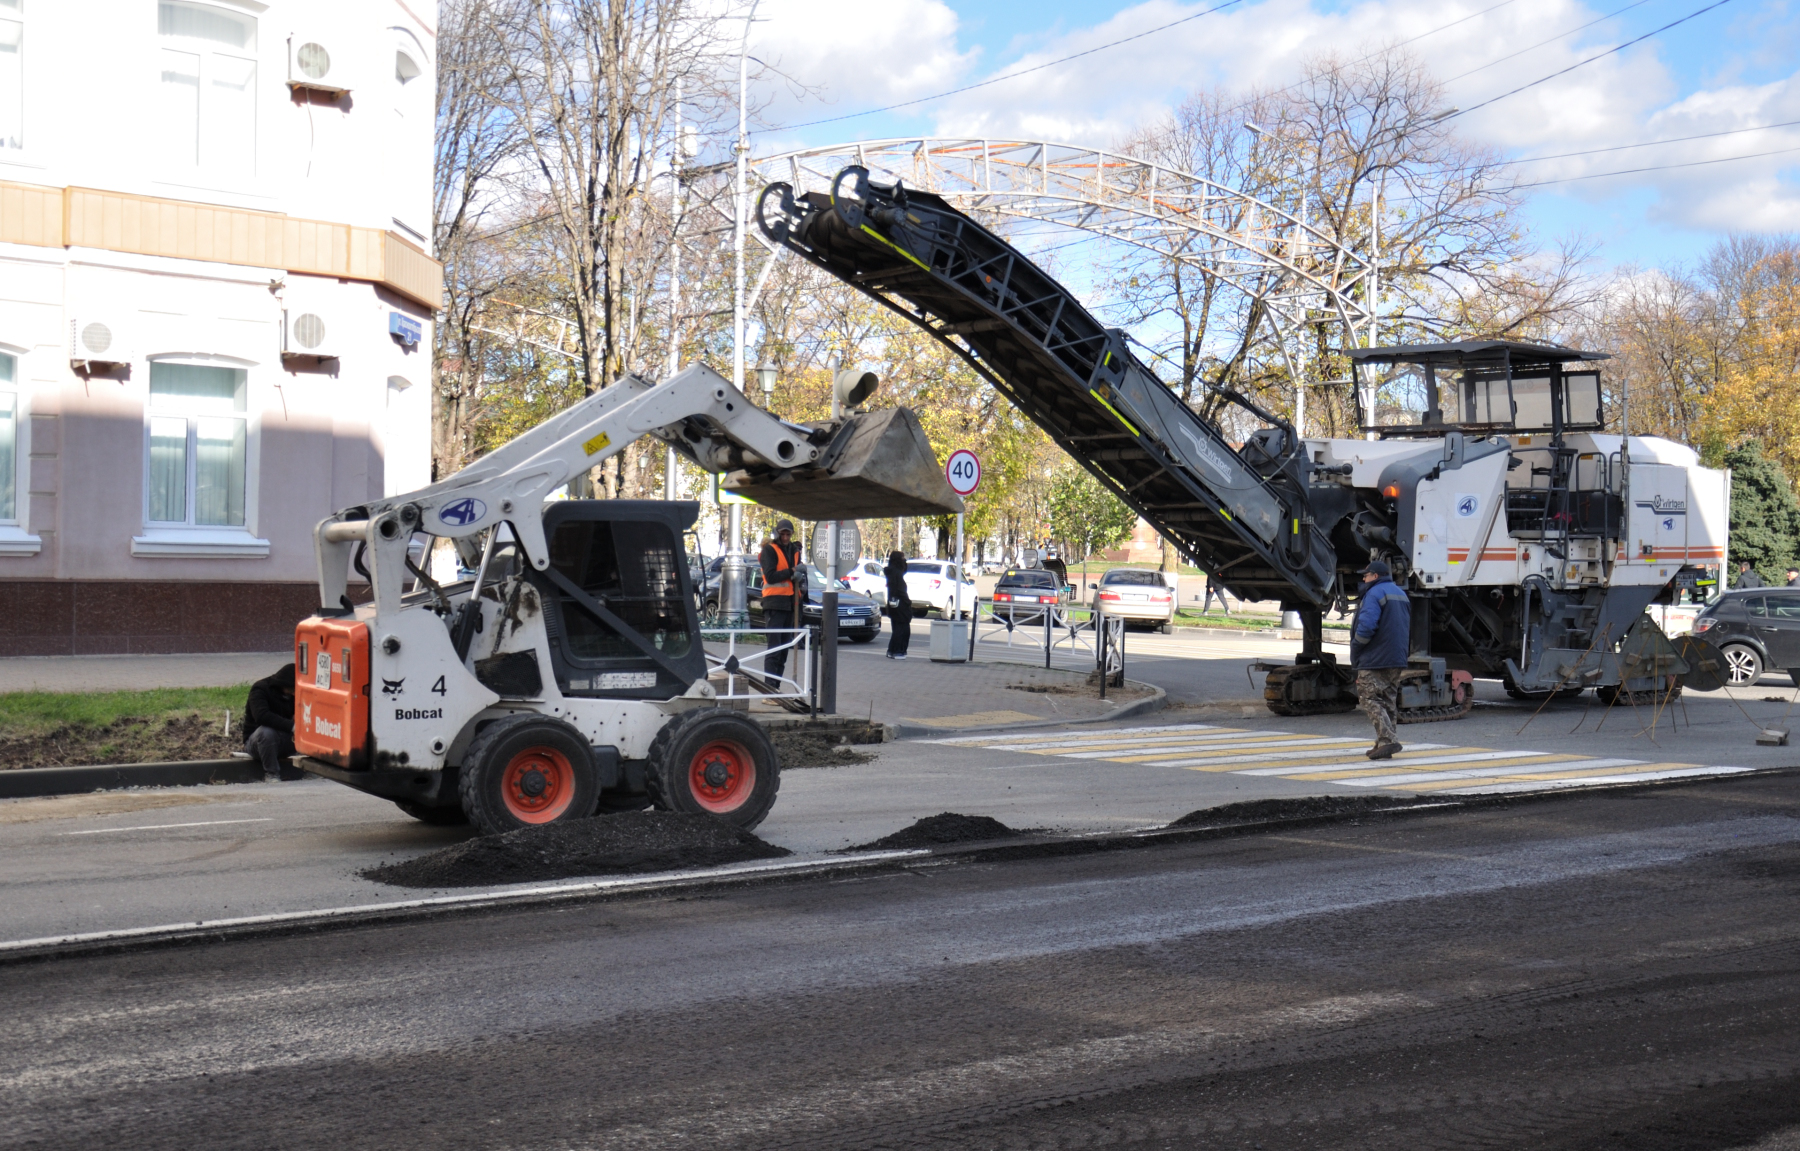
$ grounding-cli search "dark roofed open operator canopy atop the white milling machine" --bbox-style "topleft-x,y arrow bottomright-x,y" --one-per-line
1348,340 -> 1611,440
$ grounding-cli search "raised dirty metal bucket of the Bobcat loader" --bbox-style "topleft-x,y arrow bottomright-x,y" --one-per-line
722,407 -> 963,521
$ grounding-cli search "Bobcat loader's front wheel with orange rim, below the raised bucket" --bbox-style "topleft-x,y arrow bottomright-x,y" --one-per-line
648,708 -> 781,830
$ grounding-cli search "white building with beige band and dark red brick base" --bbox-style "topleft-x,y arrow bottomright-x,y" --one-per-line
0,0 -> 443,656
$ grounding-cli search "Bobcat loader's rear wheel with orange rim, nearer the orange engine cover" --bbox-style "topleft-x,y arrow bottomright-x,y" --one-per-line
459,713 -> 599,836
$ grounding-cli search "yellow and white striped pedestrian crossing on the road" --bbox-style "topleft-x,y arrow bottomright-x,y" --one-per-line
931,724 -> 1750,794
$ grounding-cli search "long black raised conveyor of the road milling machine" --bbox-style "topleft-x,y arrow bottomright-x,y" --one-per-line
756,168 -> 1337,607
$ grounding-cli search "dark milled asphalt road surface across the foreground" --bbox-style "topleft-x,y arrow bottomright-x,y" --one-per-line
0,775 -> 1800,1151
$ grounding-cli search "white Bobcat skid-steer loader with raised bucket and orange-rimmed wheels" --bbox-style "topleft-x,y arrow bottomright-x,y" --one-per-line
293,364 -> 961,832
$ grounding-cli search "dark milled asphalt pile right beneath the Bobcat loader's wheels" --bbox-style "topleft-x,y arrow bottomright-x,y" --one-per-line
362,811 -> 790,888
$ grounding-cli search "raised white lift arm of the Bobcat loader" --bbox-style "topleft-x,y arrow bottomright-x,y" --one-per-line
315,364 -> 961,614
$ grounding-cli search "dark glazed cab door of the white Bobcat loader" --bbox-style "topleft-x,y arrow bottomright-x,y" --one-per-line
535,499 -> 706,699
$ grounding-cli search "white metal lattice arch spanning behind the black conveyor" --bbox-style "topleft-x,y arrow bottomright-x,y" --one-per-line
752,137 -> 1373,342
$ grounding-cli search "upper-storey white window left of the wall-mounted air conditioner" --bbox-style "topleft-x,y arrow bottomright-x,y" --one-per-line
156,0 -> 256,175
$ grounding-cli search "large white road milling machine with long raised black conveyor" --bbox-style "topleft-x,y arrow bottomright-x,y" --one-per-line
756,168 -> 1726,722
